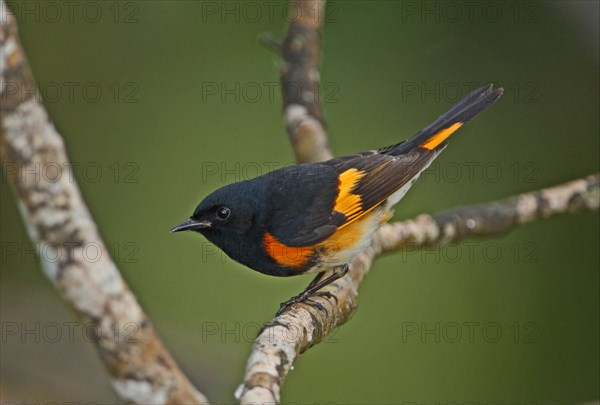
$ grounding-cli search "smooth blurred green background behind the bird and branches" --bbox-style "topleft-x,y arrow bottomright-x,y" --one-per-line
0,1 -> 600,404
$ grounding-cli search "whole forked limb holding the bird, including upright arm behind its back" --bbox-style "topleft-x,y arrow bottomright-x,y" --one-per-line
235,0 -> 600,404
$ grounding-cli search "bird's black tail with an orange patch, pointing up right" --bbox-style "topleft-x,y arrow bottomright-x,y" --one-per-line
380,84 -> 504,155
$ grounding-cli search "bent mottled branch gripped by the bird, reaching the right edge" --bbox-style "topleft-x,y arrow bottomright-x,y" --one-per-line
237,174 -> 600,404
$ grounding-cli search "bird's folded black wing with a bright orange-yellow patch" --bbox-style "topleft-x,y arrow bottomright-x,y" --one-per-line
267,149 -> 438,247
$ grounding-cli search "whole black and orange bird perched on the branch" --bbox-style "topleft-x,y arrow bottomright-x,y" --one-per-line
171,85 -> 503,314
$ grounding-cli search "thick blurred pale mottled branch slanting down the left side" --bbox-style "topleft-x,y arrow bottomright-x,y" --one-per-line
0,0 -> 207,404
